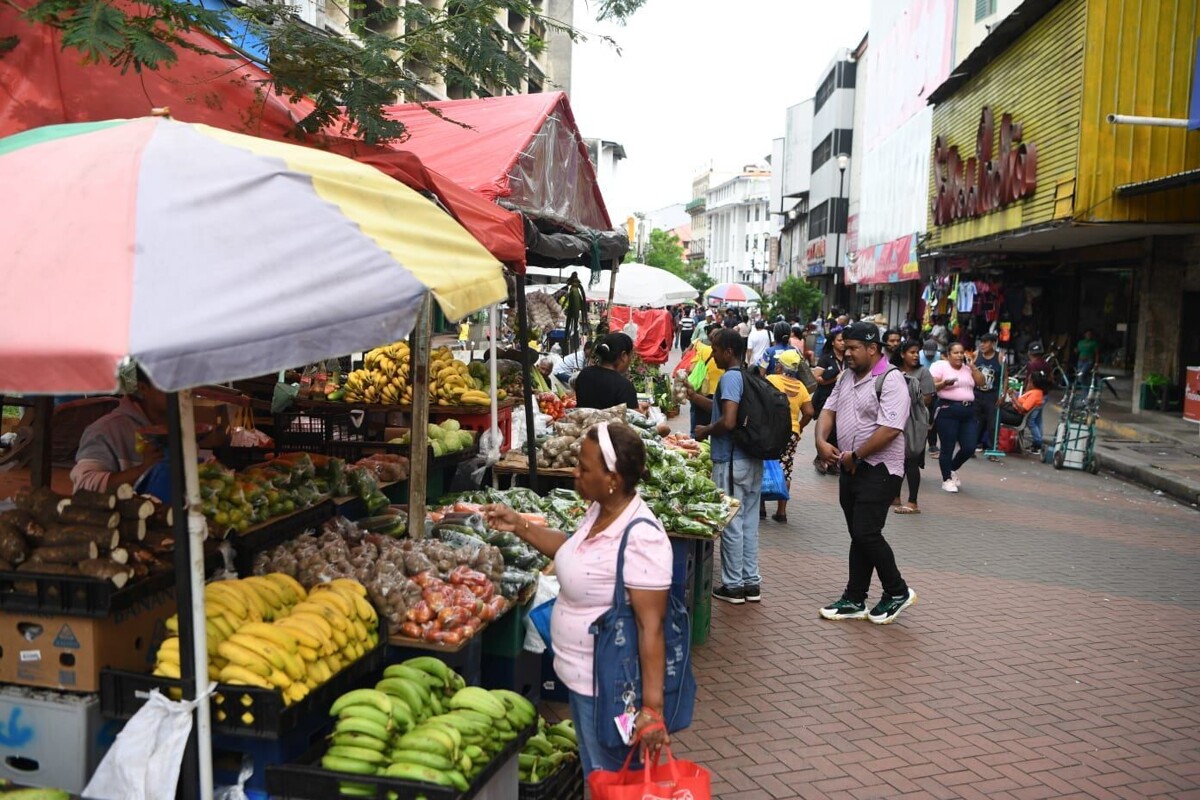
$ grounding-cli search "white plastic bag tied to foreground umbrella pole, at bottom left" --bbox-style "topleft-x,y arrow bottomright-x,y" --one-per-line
83,684 -> 216,800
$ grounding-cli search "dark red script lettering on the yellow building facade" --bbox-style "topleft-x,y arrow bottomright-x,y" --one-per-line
934,106 -> 1038,225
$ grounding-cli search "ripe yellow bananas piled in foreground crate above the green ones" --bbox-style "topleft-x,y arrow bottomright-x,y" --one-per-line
154,573 -> 379,717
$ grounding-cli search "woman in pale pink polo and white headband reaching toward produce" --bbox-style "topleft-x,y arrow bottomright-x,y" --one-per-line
484,423 -> 672,776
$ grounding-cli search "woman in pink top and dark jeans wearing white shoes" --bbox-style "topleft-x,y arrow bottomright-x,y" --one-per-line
929,342 -> 984,492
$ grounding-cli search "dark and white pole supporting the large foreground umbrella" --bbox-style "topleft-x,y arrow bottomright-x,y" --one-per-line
167,391 -> 212,798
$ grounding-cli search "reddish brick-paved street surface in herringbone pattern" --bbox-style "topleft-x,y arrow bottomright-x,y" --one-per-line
676,453 -> 1200,800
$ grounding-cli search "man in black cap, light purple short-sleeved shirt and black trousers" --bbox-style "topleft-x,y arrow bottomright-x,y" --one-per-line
816,323 -> 917,625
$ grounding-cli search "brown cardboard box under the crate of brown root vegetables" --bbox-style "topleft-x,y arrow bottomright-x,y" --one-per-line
0,590 -> 175,692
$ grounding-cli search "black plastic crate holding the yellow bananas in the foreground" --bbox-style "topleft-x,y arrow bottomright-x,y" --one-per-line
100,618 -> 388,739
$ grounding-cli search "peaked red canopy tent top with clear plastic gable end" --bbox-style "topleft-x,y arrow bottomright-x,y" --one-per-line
386,92 -> 612,230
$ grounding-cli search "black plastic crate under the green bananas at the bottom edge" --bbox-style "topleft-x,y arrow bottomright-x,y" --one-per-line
266,723 -> 538,800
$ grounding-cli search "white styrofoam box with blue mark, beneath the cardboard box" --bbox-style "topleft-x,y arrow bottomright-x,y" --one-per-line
0,686 -> 121,794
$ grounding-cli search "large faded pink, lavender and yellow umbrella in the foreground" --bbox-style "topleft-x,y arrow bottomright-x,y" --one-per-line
0,118 -> 506,393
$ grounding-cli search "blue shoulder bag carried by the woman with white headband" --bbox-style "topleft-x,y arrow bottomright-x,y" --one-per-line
588,517 -> 696,747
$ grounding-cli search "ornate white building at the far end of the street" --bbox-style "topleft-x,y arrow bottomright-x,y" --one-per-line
692,166 -> 772,288
